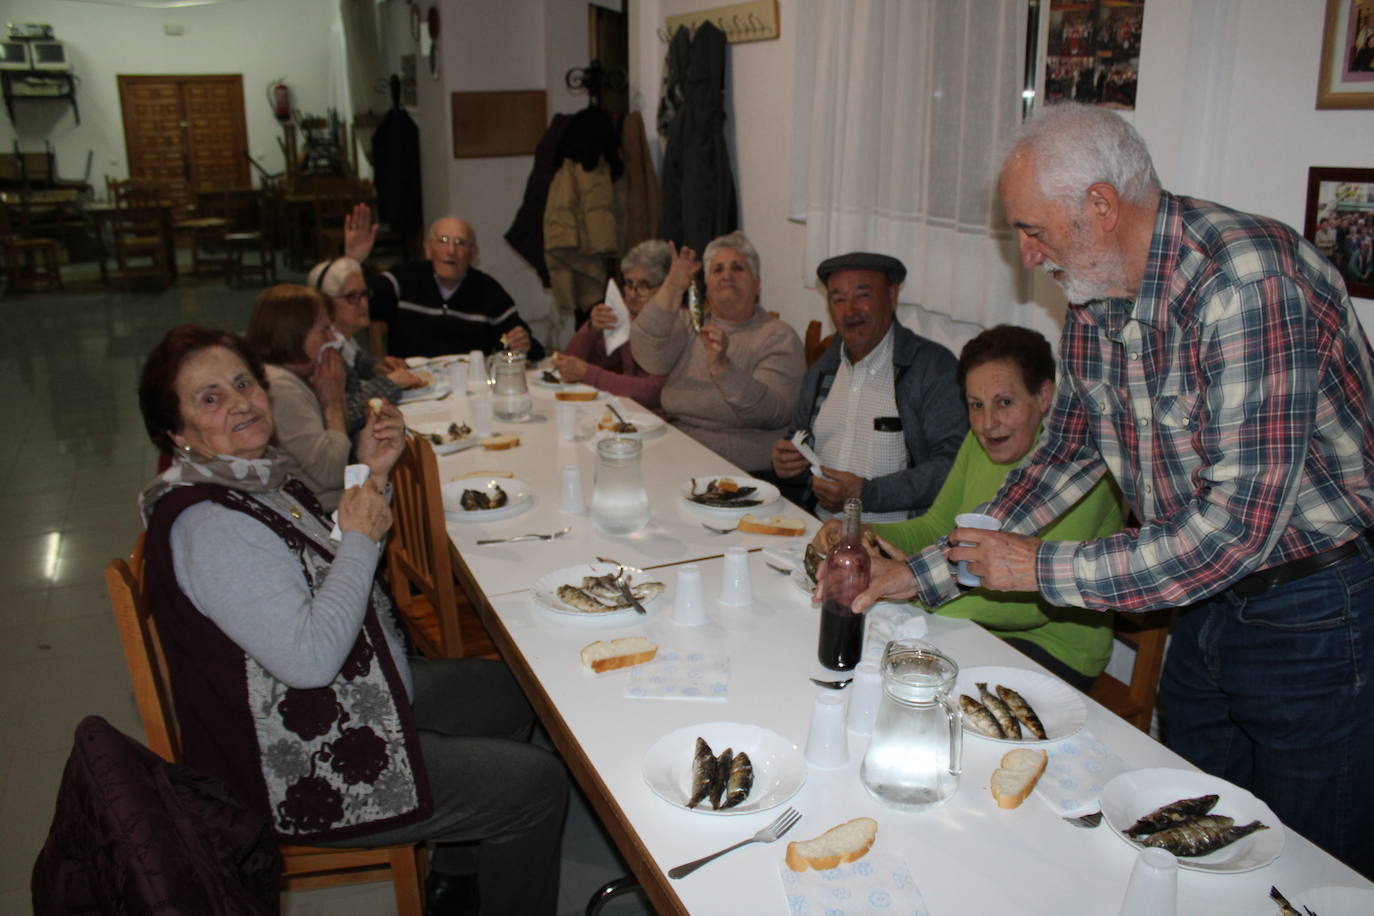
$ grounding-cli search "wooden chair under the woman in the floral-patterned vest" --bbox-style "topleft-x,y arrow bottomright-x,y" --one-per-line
104,534 -> 429,916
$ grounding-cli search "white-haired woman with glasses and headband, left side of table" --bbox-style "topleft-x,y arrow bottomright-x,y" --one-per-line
308,258 -> 423,444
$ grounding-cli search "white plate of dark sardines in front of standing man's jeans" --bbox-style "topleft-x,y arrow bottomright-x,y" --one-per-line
1098,768 -> 1280,873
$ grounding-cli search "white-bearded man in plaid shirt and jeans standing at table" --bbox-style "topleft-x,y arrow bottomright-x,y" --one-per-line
855,104 -> 1374,876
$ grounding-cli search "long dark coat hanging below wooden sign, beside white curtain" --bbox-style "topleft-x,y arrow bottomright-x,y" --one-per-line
660,22 -> 739,253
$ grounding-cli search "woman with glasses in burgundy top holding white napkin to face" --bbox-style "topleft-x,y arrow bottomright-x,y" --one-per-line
554,239 -> 672,413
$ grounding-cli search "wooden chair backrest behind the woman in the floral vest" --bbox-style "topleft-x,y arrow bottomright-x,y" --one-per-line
104,534 -> 181,764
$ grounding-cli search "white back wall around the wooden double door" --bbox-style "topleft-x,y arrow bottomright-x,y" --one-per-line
0,0 -> 338,195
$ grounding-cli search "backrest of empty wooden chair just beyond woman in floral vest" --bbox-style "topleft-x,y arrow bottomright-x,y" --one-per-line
386,434 -> 462,658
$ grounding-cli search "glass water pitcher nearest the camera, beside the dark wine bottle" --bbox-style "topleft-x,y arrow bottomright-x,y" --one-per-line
859,639 -> 963,812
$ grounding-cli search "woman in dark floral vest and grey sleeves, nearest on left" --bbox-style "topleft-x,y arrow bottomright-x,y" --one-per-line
139,325 -> 567,913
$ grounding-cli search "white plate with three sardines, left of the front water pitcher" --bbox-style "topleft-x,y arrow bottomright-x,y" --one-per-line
644,722 -> 807,817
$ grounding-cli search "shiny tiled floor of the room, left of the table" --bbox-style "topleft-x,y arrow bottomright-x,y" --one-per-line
0,272 -> 647,916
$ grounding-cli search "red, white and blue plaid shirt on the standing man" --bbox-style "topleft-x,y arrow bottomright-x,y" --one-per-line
908,192 -> 1374,611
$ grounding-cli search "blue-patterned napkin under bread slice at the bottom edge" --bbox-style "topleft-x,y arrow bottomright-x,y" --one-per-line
778,851 -> 930,916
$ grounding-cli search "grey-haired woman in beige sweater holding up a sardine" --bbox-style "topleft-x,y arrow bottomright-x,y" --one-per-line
629,232 -> 807,471
